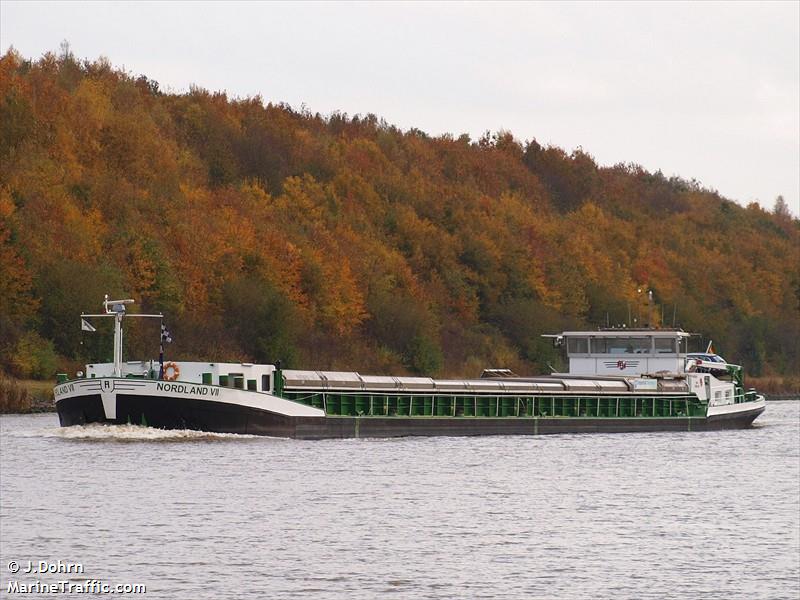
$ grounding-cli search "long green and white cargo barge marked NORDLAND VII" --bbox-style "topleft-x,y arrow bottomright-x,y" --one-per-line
54,297 -> 766,439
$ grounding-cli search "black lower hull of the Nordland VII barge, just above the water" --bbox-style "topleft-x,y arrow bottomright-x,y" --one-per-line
56,384 -> 764,439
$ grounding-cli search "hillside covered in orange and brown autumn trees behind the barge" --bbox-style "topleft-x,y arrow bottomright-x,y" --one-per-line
0,50 -> 800,377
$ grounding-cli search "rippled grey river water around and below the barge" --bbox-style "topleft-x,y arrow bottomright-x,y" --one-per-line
0,401 -> 800,600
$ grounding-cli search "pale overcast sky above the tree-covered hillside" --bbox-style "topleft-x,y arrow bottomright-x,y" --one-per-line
0,0 -> 800,215
